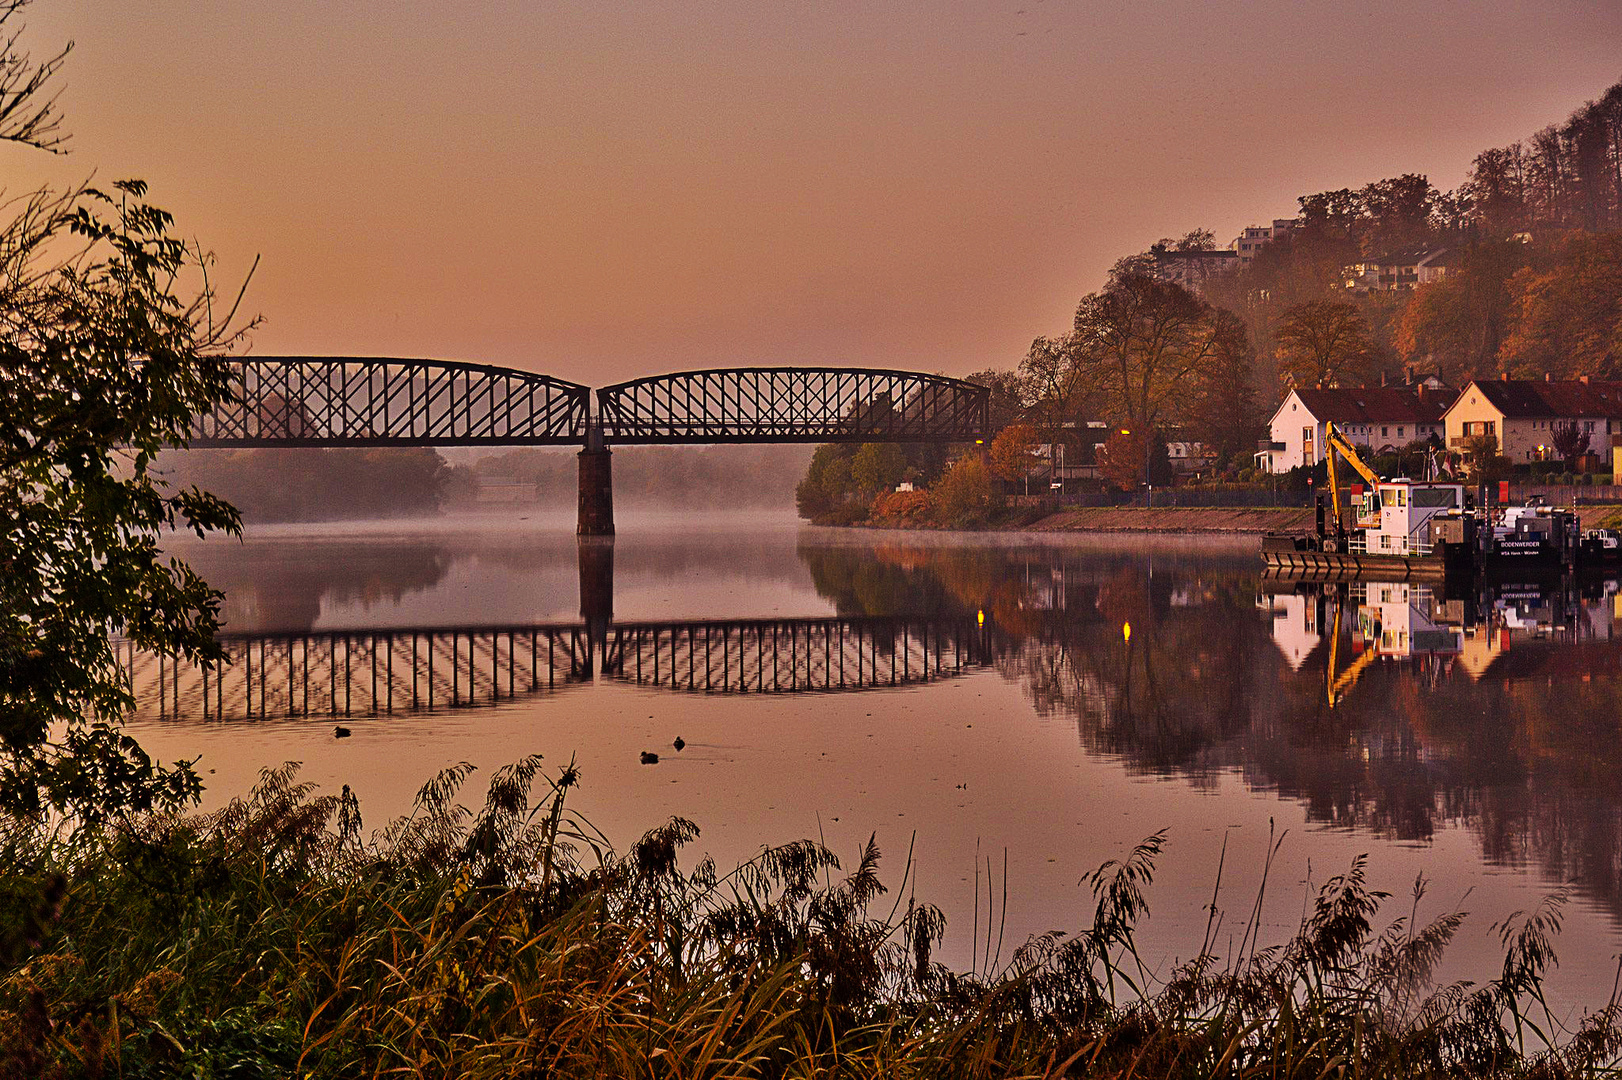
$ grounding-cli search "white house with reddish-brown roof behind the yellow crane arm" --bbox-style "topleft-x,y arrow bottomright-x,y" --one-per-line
1255,383 -> 1453,472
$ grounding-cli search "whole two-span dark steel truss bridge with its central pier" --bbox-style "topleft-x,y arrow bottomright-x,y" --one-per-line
179,357 -> 989,537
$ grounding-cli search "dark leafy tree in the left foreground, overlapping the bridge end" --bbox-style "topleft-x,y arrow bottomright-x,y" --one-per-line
0,2 -> 253,821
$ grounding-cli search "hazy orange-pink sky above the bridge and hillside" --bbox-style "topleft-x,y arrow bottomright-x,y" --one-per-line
0,0 -> 1622,384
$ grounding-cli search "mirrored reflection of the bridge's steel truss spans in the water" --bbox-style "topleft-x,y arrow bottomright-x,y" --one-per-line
117,618 -> 993,720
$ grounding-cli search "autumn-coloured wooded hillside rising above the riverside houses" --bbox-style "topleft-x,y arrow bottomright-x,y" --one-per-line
798,75 -> 1622,525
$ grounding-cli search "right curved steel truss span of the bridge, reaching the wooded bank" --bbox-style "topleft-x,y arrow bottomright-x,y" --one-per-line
597,368 -> 989,443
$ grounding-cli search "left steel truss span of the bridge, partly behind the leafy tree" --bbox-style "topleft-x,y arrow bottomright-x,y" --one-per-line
191,357 -> 590,448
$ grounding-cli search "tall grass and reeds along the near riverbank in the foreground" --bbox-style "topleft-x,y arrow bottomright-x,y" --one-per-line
0,757 -> 1622,1078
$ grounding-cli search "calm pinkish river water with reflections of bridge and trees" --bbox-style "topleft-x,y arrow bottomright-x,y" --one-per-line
131,514 -> 1622,1017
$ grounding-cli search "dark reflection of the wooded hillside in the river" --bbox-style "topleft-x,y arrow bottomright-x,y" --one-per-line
801,545 -> 1622,916
